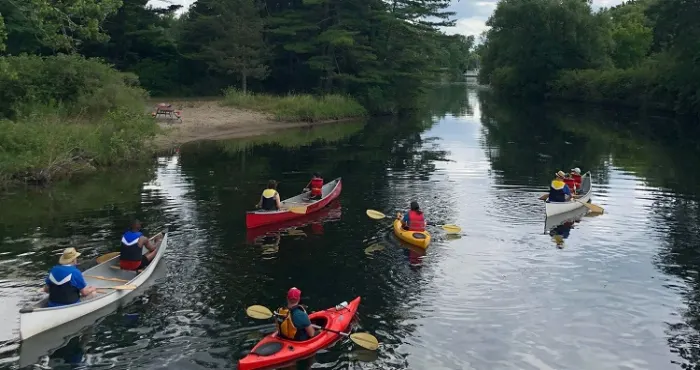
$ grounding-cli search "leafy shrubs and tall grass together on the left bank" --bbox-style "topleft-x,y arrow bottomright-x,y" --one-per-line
0,55 -> 158,185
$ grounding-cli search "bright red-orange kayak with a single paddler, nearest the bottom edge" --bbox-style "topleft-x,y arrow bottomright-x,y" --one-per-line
238,297 -> 360,370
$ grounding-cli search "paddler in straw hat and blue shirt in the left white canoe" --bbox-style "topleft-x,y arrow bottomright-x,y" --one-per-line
44,248 -> 96,307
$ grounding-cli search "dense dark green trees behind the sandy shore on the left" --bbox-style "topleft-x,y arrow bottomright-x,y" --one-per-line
0,0 -> 475,113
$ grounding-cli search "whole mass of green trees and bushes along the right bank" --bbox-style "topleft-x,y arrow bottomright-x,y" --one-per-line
479,0 -> 700,117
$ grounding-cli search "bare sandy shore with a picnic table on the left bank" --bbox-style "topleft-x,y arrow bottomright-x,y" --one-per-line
155,100 -> 360,149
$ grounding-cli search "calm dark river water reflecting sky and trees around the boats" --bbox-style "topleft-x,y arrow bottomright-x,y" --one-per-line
0,85 -> 700,370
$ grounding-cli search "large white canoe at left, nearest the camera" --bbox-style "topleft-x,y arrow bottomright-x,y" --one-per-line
19,230 -> 168,340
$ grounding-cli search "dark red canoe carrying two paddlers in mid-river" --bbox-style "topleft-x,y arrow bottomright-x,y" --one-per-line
245,177 -> 343,229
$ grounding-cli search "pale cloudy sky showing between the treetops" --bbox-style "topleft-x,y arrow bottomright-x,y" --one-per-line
151,0 -> 623,39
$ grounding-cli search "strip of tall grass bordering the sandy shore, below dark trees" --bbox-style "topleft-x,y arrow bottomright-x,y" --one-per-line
223,88 -> 367,122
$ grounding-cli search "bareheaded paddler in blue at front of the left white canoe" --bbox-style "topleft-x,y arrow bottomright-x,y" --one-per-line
119,220 -> 163,271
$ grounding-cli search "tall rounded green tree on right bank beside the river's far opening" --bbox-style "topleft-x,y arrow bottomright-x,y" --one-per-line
479,0 -> 607,96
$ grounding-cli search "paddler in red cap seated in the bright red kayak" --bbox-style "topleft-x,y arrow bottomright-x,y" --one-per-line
275,288 -> 316,340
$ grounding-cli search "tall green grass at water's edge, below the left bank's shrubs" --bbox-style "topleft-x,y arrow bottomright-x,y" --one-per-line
0,109 -> 159,184
